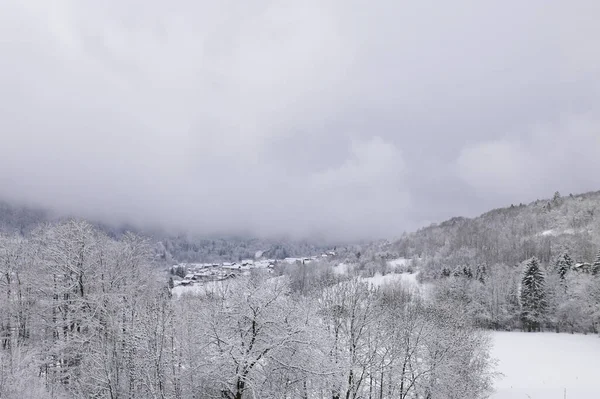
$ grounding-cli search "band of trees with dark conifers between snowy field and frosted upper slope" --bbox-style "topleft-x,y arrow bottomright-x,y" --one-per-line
433,251 -> 600,333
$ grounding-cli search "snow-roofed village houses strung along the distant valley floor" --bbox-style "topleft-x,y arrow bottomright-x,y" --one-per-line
170,251 -> 337,286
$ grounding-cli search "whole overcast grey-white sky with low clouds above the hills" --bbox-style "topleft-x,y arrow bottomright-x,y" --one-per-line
0,0 -> 600,239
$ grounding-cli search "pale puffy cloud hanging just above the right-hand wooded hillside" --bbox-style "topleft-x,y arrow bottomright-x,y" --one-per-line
457,114 -> 600,205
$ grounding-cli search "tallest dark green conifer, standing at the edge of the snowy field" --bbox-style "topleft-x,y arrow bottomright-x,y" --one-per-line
521,257 -> 546,332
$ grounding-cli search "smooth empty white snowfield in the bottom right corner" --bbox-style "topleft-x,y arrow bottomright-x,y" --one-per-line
491,332 -> 600,399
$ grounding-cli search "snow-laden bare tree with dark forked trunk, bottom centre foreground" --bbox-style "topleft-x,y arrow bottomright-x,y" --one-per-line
197,277 -> 327,399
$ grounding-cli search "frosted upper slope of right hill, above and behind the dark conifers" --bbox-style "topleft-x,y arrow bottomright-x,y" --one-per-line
389,191 -> 600,277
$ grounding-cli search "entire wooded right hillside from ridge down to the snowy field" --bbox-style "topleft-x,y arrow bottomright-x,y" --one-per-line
385,192 -> 600,333
